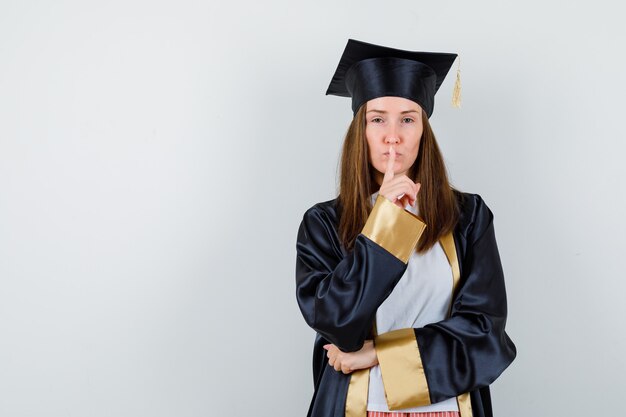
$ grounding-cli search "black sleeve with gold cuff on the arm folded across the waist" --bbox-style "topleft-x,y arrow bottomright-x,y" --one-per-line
374,197 -> 516,410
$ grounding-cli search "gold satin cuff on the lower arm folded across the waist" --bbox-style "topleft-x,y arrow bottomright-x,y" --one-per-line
375,328 -> 430,410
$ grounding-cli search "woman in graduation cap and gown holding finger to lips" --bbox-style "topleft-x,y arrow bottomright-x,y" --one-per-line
296,40 -> 516,417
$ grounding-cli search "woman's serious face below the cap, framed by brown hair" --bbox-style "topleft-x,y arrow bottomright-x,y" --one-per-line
365,97 -> 424,185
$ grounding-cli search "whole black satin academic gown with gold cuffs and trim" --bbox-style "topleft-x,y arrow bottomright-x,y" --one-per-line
296,191 -> 516,417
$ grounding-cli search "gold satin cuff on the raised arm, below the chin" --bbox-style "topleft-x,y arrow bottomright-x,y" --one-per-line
361,194 -> 426,263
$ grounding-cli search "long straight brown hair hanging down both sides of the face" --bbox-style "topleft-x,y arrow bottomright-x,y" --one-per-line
338,105 -> 459,253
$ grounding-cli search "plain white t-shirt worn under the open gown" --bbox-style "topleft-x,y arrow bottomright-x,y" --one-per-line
367,192 -> 459,412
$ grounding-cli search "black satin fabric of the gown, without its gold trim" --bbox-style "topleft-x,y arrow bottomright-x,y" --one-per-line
296,192 -> 516,417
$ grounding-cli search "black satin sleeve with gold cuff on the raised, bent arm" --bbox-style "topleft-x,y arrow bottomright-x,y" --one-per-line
296,195 -> 426,352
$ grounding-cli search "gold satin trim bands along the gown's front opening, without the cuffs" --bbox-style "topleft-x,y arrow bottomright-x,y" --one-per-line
345,233 -> 472,417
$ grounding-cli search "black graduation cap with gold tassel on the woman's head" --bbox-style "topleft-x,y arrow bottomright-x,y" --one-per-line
326,39 -> 461,117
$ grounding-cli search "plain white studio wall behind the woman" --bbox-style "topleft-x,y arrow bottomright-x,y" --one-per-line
0,0 -> 626,417
